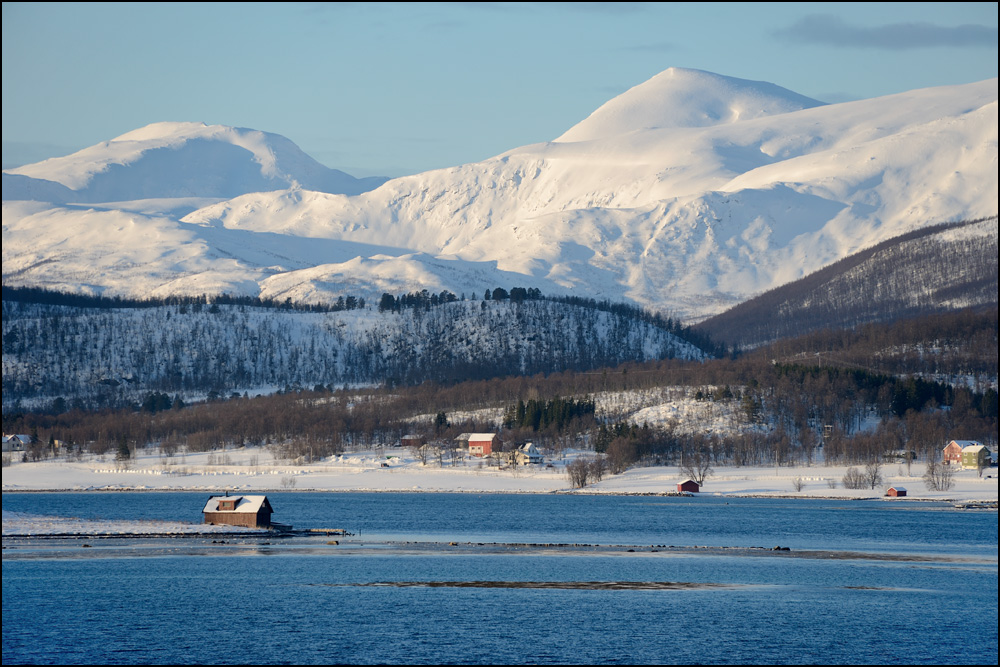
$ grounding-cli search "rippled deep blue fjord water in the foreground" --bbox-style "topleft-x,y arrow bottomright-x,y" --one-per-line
3,493 -> 997,664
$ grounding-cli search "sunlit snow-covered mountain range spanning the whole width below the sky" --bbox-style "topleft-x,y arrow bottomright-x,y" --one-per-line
3,68 -> 998,320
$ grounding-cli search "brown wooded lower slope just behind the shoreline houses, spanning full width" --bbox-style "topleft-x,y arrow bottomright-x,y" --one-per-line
4,310 -> 998,471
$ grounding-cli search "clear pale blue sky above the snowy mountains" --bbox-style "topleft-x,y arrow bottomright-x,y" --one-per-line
2,2 -> 998,177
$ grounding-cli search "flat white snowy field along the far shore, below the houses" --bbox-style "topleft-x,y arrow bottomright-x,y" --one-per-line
3,447 -> 998,502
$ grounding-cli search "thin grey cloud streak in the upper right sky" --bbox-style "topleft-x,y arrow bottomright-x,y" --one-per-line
772,14 -> 997,51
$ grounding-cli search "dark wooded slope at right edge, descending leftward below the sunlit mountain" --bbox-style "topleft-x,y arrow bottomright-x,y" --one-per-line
698,217 -> 997,348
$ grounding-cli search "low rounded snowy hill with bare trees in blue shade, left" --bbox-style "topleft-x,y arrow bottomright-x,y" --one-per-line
3,288 -> 705,412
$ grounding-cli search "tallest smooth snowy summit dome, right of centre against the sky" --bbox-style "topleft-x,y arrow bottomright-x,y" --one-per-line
556,67 -> 823,142
